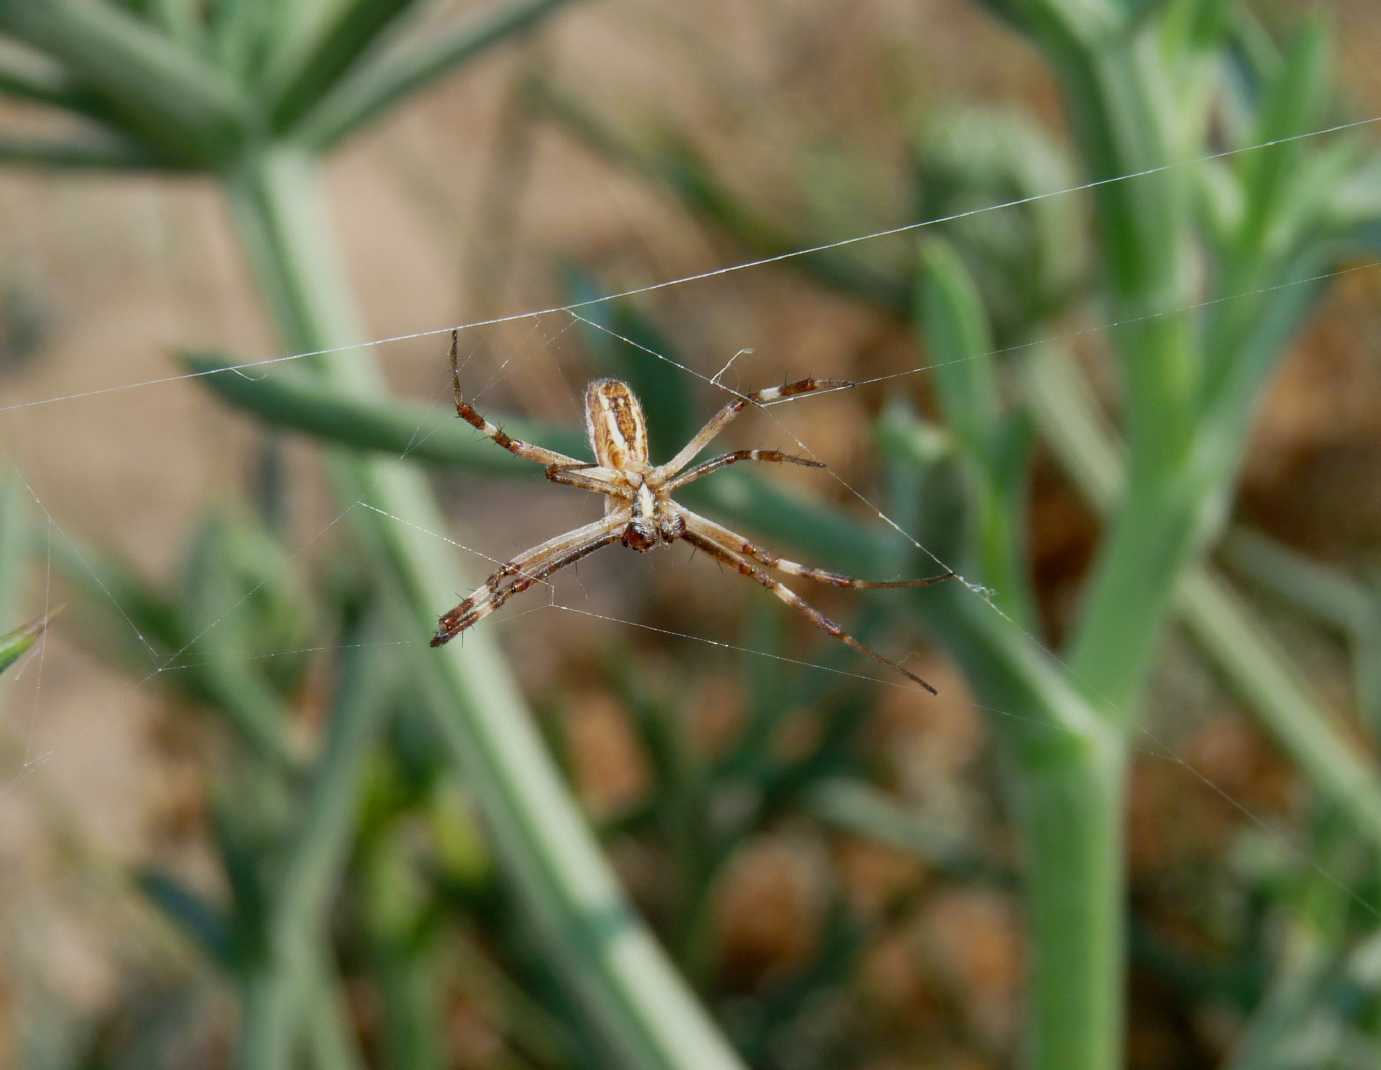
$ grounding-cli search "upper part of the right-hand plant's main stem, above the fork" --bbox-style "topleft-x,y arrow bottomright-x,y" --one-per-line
1048,32 -> 1211,725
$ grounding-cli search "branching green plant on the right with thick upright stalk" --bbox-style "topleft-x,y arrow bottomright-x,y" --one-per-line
519,0 -> 1381,1070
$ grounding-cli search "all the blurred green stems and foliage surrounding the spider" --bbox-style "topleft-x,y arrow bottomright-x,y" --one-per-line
0,0 -> 1381,1070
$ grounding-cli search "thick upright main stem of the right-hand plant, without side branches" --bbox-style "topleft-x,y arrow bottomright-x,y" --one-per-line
972,39 -> 1208,1070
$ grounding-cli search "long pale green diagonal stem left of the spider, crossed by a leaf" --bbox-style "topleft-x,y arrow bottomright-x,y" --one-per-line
229,149 -> 737,1070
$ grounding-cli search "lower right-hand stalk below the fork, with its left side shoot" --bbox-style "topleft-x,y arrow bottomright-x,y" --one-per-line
918,590 -> 1126,1070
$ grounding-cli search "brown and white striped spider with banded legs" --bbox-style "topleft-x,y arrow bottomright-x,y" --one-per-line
431,331 -> 954,694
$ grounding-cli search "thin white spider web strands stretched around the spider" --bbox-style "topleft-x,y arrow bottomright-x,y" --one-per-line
0,52 -> 1381,1054
